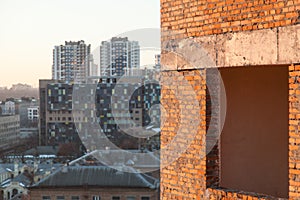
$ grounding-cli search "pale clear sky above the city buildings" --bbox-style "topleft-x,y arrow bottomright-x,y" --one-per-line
0,0 -> 160,87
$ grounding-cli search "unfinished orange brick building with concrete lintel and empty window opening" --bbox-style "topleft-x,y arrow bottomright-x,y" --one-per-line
161,0 -> 300,200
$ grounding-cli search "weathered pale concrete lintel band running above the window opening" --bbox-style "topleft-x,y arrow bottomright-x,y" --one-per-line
162,25 -> 300,71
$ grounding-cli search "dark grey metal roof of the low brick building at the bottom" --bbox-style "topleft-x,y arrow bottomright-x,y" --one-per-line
32,166 -> 159,189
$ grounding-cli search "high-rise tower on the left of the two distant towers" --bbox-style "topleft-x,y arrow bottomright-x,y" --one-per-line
52,40 -> 91,82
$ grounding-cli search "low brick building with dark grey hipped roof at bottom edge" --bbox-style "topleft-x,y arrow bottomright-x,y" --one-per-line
30,166 -> 159,200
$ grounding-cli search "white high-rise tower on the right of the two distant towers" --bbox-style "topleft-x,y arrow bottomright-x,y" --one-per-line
100,37 -> 140,76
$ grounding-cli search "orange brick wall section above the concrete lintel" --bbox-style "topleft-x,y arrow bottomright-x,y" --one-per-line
161,0 -> 300,37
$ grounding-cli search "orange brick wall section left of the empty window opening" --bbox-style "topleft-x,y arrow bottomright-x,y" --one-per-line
161,71 -> 206,200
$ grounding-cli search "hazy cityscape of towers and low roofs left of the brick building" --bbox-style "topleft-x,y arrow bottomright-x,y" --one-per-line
0,37 -> 161,200
